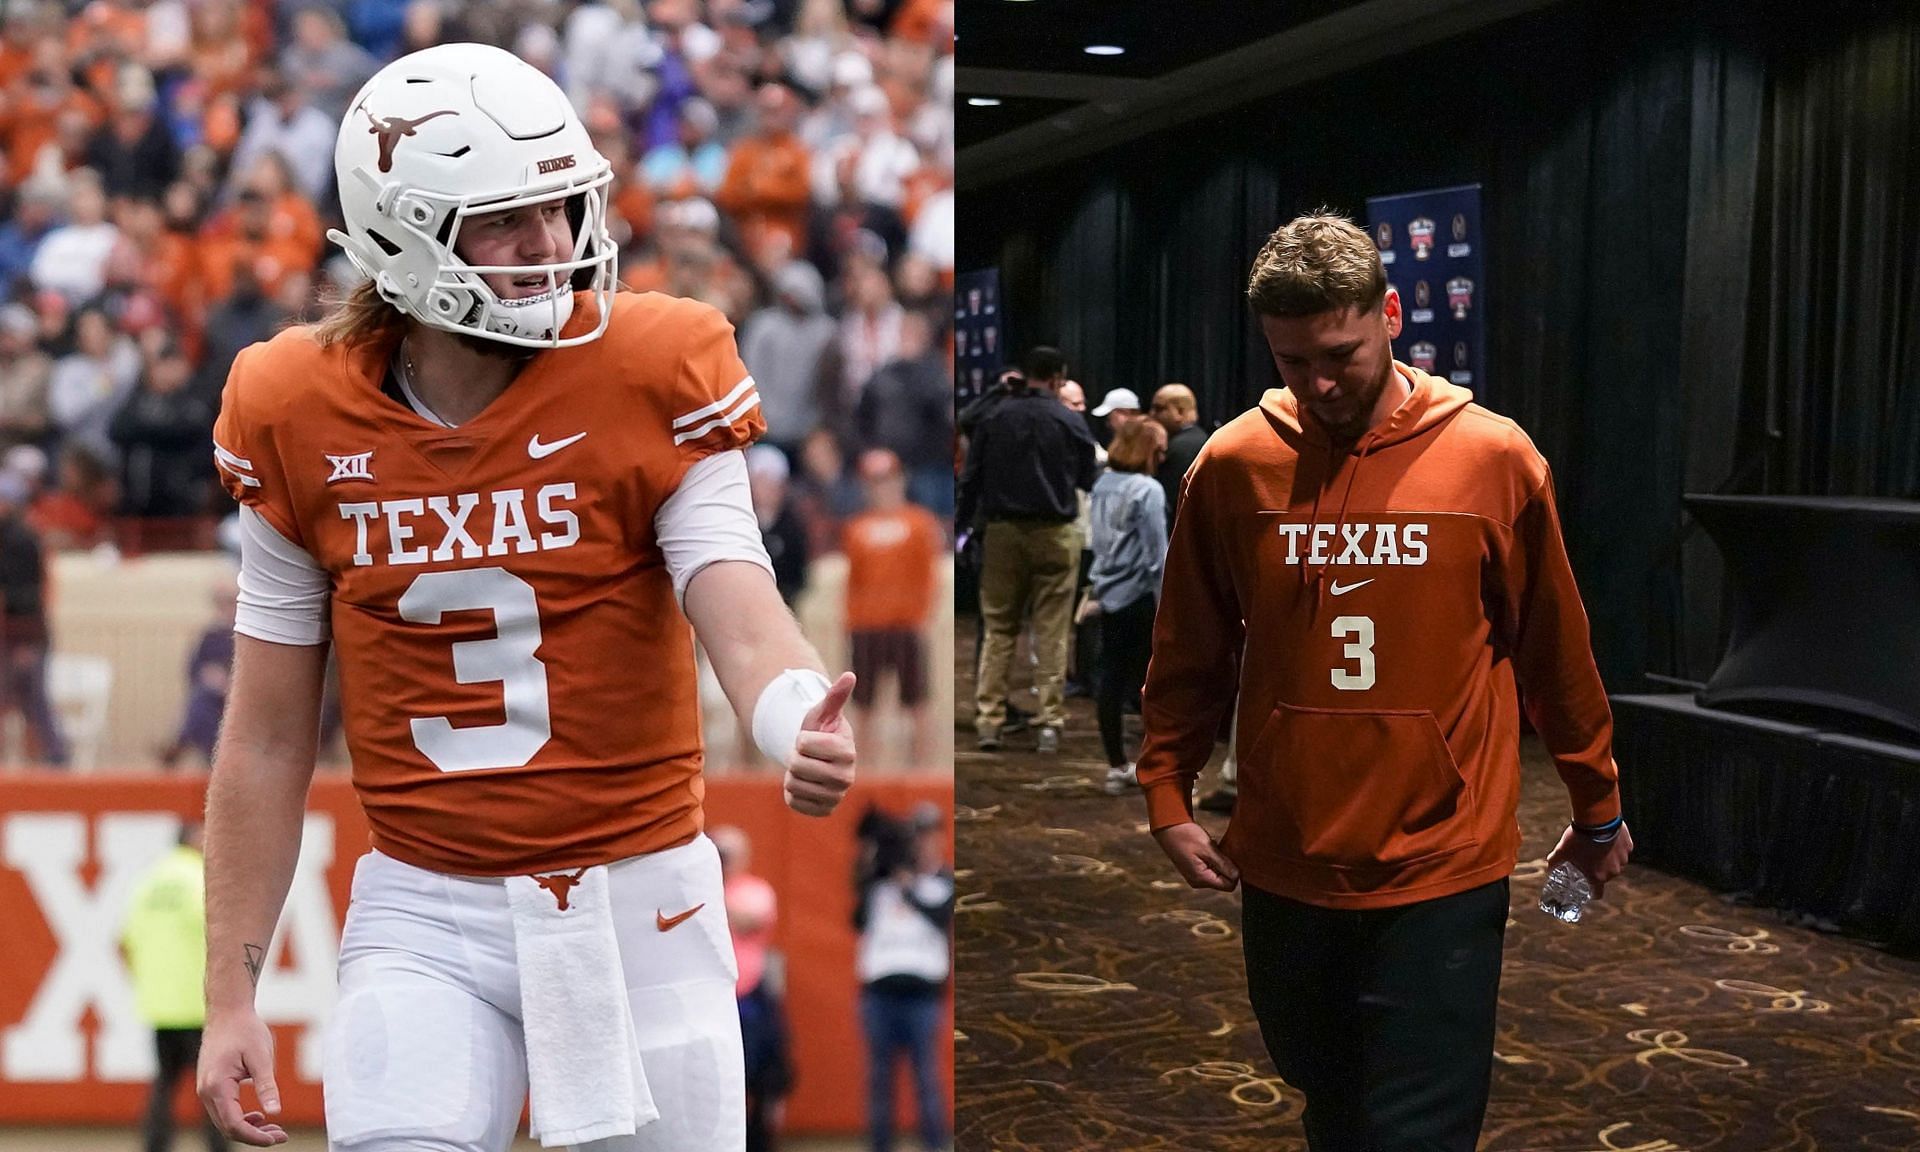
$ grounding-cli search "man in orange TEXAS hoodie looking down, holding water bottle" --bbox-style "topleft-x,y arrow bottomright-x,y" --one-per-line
1139,215 -> 1634,1152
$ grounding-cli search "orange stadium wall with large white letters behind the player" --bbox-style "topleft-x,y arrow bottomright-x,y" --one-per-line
0,774 -> 952,1133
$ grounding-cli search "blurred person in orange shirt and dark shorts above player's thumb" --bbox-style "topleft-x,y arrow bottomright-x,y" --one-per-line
841,447 -> 947,768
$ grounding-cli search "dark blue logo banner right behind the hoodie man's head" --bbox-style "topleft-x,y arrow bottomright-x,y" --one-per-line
1367,184 -> 1486,393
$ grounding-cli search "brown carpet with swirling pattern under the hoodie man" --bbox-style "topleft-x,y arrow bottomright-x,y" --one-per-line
954,620 -> 1920,1152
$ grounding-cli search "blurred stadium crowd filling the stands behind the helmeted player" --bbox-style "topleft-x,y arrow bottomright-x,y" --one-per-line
0,0 -> 954,768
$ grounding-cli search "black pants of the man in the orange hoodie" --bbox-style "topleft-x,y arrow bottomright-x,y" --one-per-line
1240,879 -> 1507,1152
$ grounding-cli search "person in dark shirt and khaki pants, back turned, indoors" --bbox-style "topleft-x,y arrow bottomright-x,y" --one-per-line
956,346 -> 1094,753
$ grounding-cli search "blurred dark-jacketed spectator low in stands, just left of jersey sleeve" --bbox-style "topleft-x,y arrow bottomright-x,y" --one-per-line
109,332 -> 215,516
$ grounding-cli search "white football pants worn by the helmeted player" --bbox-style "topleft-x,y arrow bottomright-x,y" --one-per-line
324,835 -> 747,1152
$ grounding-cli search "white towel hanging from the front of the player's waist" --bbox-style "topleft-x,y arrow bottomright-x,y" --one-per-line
507,866 -> 660,1148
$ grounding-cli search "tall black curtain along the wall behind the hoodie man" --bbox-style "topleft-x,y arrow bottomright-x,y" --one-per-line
960,0 -> 1920,687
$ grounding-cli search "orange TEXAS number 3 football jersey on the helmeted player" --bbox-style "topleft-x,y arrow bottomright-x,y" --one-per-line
213,294 -> 764,876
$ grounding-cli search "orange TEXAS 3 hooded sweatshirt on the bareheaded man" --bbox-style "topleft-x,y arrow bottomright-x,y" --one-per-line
1139,363 -> 1620,908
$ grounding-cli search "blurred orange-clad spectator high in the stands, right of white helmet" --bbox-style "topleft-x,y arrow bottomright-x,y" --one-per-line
714,84 -> 808,269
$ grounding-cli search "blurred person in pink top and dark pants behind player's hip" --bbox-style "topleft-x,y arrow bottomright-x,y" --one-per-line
707,826 -> 793,1152
